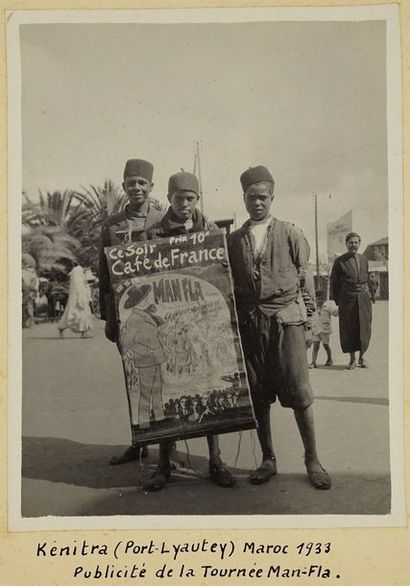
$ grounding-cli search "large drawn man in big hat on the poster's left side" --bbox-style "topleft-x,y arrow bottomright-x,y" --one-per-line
120,285 -> 165,428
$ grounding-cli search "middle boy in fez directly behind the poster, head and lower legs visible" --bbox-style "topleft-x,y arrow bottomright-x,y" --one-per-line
143,172 -> 235,491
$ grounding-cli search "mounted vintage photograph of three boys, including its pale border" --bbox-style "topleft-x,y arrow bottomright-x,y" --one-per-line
8,8 -> 403,529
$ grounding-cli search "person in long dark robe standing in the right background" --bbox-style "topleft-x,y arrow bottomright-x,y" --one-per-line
330,232 -> 372,370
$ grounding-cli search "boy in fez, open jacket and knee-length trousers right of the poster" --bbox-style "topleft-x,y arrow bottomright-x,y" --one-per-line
229,166 -> 331,489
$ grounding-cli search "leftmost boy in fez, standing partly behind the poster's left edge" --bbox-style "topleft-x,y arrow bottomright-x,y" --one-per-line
99,159 -> 163,464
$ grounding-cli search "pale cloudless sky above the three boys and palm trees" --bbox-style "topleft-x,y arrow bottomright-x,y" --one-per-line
20,21 -> 388,255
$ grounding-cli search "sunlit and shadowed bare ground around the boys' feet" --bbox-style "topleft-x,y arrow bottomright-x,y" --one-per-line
22,302 -> 391,517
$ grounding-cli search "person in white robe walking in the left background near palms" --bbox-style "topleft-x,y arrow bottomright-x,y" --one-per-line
57,264 -> 93,337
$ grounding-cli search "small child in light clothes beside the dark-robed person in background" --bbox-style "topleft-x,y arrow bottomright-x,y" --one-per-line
309,291 -> 339,368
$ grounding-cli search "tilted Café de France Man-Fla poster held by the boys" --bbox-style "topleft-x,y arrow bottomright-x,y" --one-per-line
105,230 -> 255,444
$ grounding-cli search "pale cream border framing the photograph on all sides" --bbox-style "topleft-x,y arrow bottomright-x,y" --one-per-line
7,5 -> 406,531
